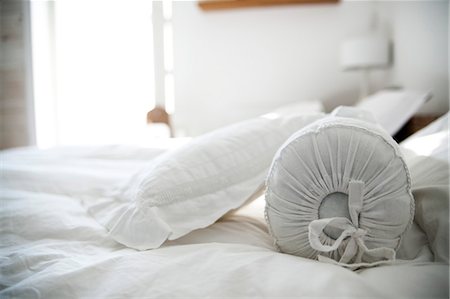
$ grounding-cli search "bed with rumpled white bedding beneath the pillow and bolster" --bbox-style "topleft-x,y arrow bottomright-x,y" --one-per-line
0,103 -> 449,298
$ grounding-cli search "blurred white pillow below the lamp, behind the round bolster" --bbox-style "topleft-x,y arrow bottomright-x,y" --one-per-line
356,90 -> 431,136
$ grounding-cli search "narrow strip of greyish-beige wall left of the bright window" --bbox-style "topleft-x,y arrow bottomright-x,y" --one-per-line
0,1 -> 34,149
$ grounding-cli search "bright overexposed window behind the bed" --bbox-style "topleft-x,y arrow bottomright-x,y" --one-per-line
31,0 -> 155,147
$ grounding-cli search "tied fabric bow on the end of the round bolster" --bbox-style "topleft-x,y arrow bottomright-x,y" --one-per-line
308,181 -> 395,265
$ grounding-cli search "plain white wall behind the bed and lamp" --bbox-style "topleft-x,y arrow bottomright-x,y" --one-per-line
173,1 -> 449,135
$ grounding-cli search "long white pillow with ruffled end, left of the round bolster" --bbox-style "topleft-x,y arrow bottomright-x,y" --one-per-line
90,114 -> 323,250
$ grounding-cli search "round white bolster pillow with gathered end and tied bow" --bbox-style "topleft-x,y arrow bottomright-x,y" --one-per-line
265,110 -> 414,267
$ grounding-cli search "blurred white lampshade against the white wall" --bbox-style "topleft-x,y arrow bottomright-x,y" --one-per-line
341,36 -> 390,70
